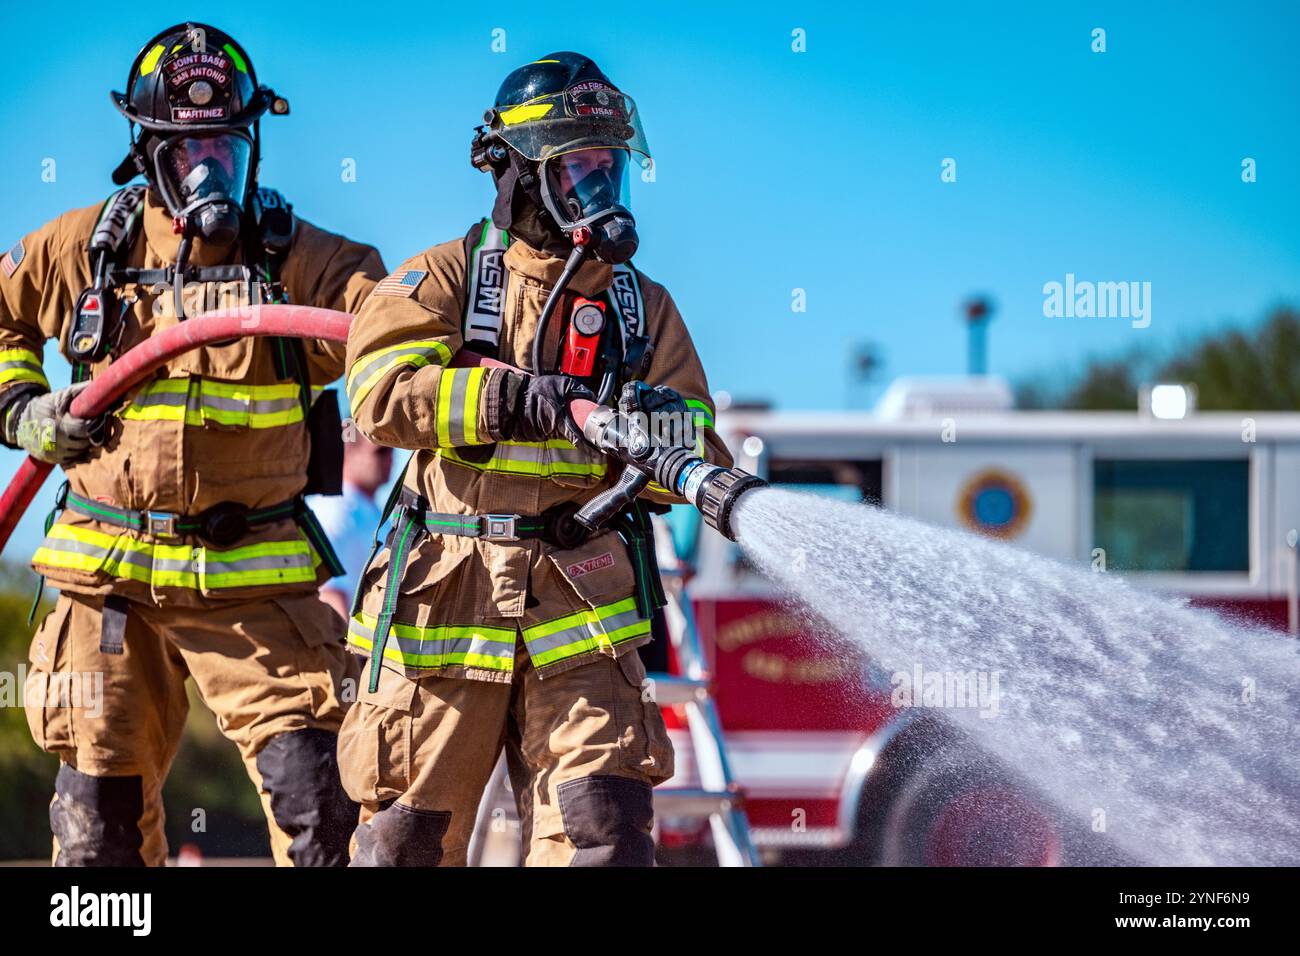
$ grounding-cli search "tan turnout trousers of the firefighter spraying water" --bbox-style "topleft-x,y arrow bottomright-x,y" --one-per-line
339,640 -> 673,866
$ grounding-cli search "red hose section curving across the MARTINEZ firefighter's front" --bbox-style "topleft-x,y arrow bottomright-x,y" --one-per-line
0,306 -> 352,551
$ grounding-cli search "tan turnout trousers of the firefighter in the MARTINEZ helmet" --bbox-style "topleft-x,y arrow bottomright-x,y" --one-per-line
26,593 -> 356,866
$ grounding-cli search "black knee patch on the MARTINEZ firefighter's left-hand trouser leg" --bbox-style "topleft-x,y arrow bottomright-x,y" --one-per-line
49,763 -> 144,866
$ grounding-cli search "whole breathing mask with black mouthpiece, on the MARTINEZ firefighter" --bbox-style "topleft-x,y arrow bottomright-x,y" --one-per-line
153,131 -> 252,245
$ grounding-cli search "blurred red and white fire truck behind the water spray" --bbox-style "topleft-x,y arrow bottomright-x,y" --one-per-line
660,377 -> 1300,865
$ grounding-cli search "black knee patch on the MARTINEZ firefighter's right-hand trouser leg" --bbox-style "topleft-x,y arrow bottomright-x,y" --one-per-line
257,727 -> 359,866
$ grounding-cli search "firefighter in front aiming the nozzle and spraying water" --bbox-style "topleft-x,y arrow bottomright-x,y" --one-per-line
339,53 -> 729,865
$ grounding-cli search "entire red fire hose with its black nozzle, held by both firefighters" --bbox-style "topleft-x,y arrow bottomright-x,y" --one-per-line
0,304 -> 766,551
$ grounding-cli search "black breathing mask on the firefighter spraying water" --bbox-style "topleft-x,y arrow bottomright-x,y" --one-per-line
540,146 -> 640,263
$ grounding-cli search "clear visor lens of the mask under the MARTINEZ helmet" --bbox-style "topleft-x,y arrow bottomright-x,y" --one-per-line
153,130 -> 252,216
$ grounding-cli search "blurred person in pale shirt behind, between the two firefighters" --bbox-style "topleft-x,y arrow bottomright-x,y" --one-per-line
311,432 -> 393,620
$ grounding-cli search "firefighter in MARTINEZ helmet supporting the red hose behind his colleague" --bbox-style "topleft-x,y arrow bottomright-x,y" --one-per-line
0,23 -> 385,865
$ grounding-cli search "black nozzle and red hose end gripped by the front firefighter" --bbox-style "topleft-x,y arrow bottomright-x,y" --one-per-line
451,349 -> 767,541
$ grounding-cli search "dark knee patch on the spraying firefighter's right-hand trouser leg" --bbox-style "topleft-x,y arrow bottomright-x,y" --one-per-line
555,775 -> 654,866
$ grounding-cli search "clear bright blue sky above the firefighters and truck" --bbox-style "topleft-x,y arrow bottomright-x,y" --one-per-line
0,0 -> 1300,550
